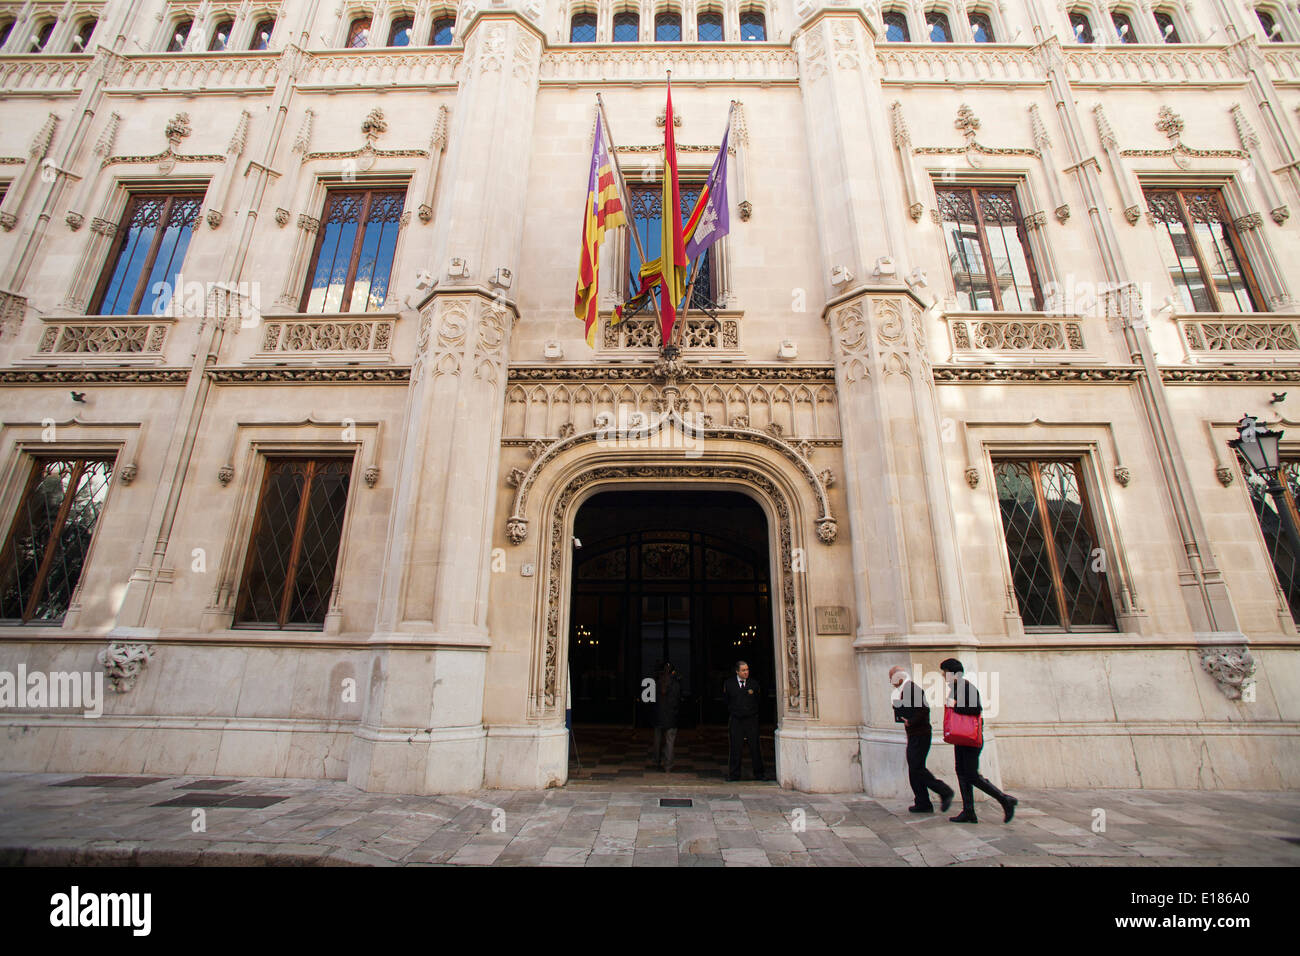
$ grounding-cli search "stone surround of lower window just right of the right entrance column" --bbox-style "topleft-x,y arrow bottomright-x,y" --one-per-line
965,434 -> 1145,639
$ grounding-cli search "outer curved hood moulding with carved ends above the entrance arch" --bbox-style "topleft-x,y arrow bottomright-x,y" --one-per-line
506,408 -> 839,545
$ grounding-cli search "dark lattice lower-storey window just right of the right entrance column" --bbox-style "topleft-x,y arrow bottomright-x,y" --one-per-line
993,458 -> 1115,631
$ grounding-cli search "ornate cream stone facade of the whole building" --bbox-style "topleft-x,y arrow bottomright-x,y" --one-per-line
0,0 -> 1300,796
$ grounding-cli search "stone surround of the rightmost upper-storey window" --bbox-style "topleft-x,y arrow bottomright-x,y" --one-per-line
1136,169 -> 1291,321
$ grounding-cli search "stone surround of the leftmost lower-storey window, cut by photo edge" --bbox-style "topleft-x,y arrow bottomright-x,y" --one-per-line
0,434 -> 133,635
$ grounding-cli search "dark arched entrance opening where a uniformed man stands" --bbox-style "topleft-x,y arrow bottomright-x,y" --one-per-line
568,490 -> 780,780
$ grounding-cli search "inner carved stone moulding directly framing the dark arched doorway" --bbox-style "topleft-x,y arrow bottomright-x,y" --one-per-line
528,455 -> 816,719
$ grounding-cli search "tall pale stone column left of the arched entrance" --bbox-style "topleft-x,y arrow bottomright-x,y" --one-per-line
348,10 -> 542,793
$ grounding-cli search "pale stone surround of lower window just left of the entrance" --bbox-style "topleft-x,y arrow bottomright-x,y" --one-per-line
205,437 -> 381,636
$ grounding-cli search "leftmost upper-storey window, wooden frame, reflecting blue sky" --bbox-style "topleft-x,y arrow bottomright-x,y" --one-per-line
92,193 -> 203,315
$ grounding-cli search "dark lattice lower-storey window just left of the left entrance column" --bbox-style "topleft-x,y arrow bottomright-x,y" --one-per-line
234,458 -> 352,630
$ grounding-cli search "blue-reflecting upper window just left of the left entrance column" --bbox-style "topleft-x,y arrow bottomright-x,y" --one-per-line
300,189 -> 406,313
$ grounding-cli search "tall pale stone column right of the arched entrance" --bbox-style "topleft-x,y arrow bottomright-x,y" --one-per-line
798,7 -> 974,795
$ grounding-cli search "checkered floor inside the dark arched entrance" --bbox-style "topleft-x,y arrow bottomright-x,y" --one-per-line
569,724 -> 776,783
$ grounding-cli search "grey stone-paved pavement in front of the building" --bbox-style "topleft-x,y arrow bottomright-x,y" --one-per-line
0,774 -> 1300,866
